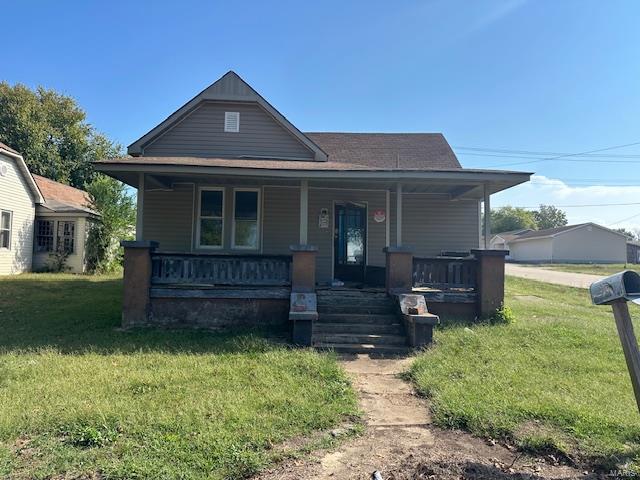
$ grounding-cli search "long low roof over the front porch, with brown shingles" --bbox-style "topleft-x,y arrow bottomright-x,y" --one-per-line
95,157 -> 532,198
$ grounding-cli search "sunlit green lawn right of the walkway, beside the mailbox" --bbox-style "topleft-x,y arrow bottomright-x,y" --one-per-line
410,277 -> 640,466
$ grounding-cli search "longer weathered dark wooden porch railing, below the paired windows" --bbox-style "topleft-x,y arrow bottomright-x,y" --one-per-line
151,253 -> 291,286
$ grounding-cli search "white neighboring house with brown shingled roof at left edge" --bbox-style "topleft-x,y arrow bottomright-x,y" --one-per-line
0,143 -> 99,275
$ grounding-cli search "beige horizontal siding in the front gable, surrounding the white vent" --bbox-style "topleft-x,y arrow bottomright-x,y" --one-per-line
144,102 -> 314,159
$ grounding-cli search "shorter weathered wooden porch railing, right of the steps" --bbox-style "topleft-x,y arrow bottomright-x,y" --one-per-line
413,257 -> 478,290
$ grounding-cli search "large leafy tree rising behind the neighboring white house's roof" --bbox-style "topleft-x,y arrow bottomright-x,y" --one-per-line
0,82 -> 121,188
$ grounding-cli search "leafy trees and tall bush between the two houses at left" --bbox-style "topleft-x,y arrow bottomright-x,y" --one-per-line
0,82 -> 136,272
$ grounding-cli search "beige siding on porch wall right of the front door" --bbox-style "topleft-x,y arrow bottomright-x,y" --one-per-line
400,194 -> 479,257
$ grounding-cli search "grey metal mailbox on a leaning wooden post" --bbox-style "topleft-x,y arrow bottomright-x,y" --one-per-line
589,270 -> 640,410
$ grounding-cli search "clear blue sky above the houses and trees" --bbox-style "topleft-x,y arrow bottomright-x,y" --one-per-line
5,0 -> 640,228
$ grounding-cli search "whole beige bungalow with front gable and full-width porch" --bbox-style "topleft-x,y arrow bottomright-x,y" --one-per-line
96,72 -> 530,348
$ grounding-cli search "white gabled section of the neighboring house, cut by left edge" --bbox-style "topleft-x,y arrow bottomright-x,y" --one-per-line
0,143 -> 42,275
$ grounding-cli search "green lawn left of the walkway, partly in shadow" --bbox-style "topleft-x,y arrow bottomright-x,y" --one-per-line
0,274 -> 357,479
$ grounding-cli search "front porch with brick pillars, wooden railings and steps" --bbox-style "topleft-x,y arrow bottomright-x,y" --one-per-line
107,172 -> 511,349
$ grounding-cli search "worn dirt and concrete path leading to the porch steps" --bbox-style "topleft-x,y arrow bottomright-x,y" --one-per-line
256,355 -> 597,480
